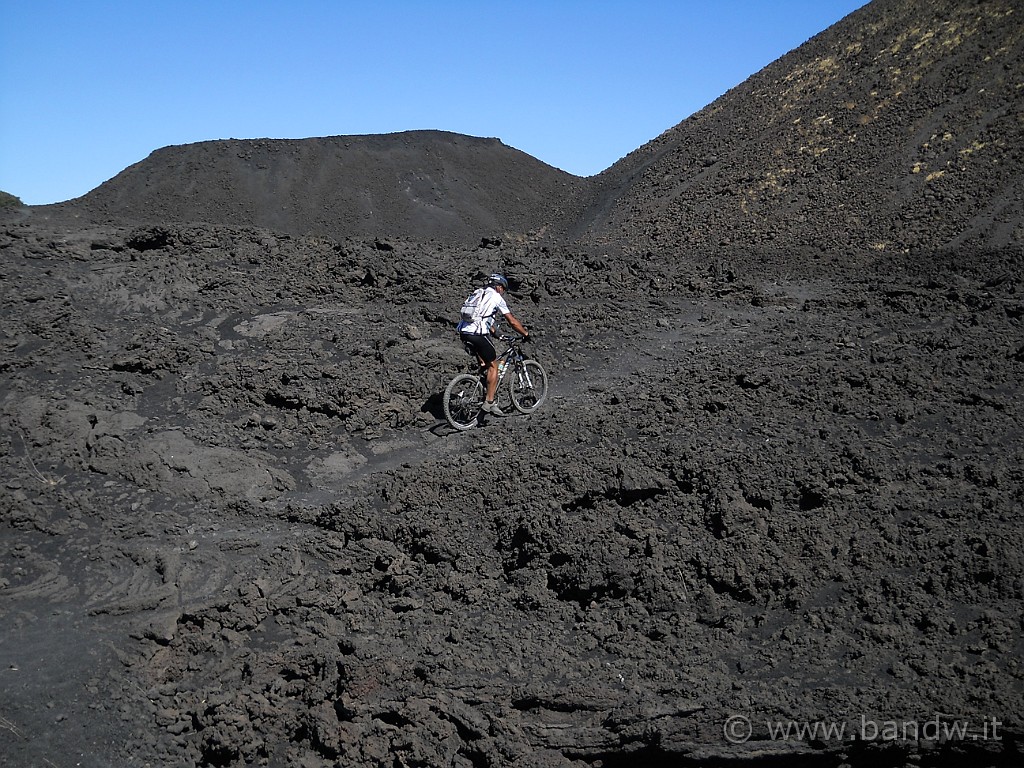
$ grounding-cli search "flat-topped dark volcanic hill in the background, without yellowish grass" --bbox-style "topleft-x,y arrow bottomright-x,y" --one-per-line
37,131 -> 583,243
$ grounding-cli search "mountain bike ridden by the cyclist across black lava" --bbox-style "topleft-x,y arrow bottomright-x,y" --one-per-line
444,336 -> 548,430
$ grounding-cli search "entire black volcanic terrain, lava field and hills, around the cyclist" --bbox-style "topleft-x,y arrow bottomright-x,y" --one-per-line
0,0 -> 1024,768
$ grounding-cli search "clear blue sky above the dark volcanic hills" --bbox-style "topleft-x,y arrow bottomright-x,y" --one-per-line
0,0 -> 865,205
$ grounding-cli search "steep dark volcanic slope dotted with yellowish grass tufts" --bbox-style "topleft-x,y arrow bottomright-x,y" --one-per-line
571,0 -> 1024,262
